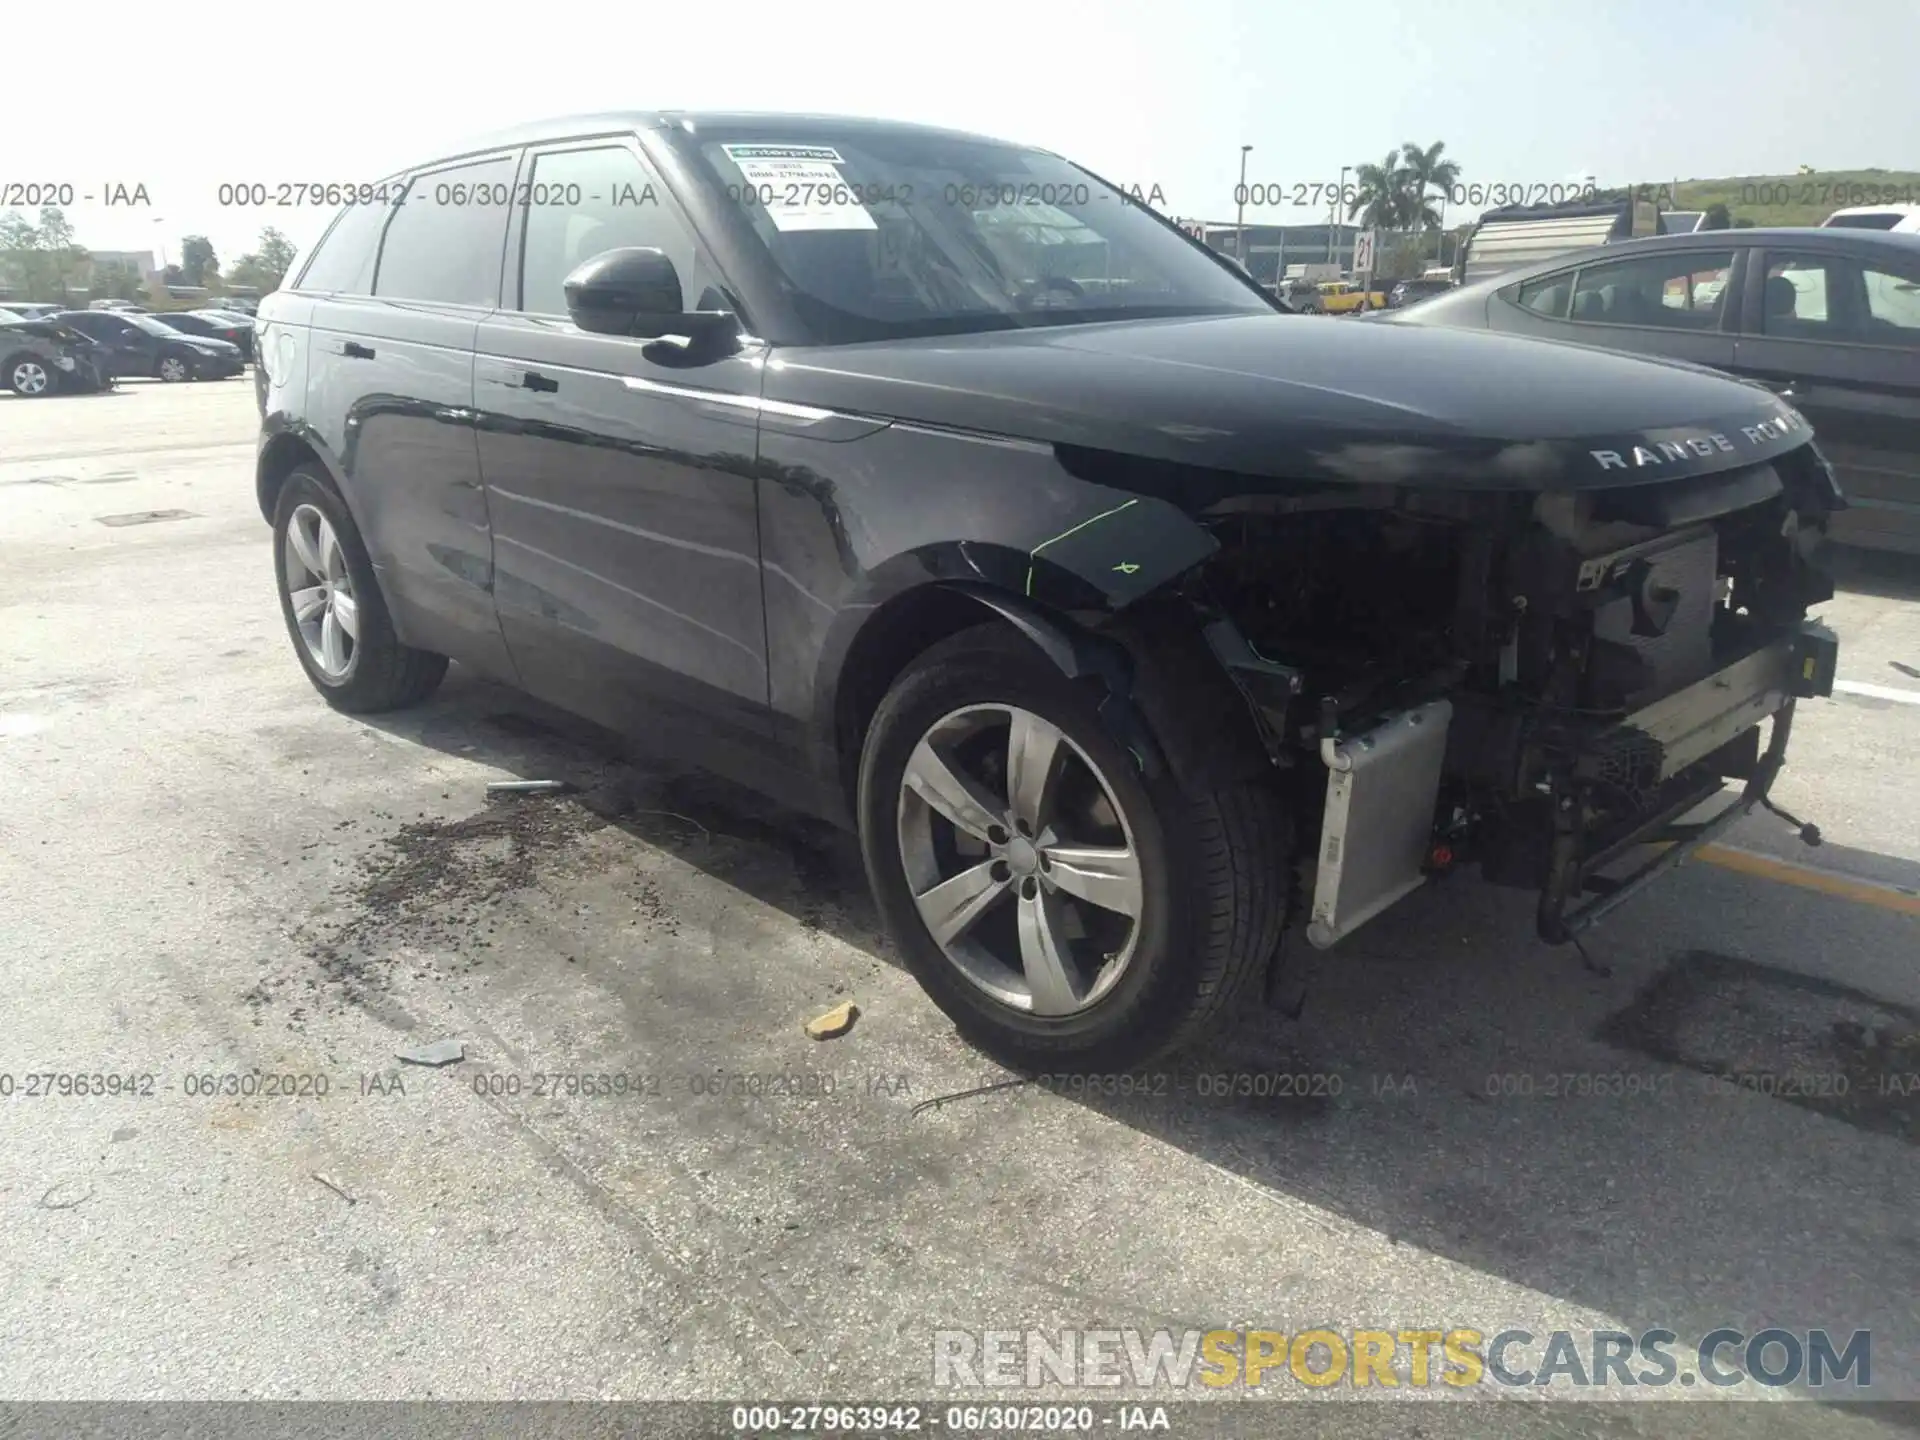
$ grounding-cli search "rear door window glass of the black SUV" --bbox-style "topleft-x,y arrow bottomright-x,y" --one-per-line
372,156 -> 513,305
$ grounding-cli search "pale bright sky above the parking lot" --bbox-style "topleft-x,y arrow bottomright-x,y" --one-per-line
0,0 -> 1920,265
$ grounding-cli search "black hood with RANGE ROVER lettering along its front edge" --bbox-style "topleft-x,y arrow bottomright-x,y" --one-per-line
764,315 -> 1812,490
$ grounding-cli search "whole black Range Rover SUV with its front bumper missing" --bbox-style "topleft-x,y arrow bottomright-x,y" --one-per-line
257,113 -> 1843,1068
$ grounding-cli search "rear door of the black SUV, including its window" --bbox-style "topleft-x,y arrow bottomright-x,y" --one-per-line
301,159 -> 518,678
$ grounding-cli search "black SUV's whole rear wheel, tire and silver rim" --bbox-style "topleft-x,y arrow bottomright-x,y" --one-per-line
273,465 -> 447,714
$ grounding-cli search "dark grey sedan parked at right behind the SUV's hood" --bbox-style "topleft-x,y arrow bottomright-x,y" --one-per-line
1394,227 -> 1920,553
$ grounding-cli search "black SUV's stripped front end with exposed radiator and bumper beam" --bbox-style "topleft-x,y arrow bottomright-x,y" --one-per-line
1144,442 -> 1845,960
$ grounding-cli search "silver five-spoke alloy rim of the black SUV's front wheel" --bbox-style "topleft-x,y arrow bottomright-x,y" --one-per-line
899,705 -> 1144,1018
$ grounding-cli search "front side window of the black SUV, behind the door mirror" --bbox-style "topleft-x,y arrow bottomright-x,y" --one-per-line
520,144 -> 733,315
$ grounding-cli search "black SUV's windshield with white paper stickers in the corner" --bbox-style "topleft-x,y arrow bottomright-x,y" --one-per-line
689,121 -> 1273,344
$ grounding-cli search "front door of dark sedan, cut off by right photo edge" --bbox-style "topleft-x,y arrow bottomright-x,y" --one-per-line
1736,246 -> 1920,551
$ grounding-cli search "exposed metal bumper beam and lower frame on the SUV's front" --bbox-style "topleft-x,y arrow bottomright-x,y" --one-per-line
1538,622 -> 1837,943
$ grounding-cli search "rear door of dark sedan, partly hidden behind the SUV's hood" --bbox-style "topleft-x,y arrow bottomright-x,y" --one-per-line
1488,246 -> 1736,371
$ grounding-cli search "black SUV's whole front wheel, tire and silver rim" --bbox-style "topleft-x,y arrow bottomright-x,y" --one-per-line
858,626 -> 1290,1073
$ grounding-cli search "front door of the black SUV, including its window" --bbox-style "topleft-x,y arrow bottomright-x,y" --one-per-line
476,134 -> 768,774
